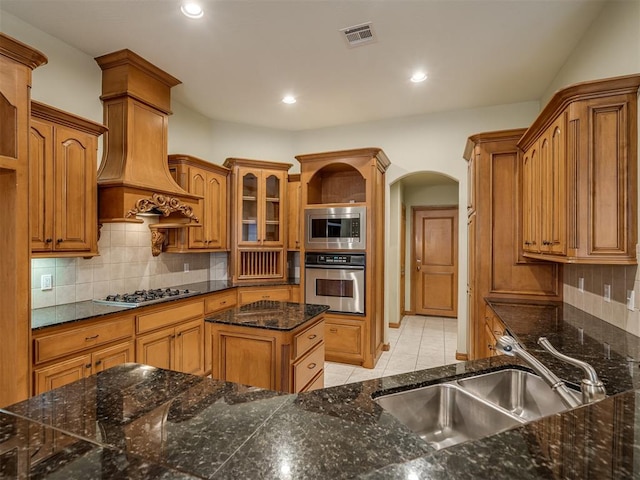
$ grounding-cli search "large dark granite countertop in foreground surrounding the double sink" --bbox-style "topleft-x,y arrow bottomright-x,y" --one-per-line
0,303 -> 640,480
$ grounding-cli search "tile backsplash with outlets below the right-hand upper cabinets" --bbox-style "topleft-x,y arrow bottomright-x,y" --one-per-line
563,265 -> 640,337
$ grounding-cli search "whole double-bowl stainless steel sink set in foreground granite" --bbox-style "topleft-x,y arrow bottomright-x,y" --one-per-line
375,369 -> 579,449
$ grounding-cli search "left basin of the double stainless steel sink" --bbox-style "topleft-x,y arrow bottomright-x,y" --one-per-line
376,383 -> 522,449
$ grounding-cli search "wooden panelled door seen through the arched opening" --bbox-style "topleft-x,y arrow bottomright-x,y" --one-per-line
413,207 -> 458,317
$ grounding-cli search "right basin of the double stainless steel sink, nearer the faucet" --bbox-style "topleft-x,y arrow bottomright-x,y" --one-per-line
458,369 -> 568,421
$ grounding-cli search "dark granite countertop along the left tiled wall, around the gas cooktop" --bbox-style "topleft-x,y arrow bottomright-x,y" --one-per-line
31,278 -> 300,330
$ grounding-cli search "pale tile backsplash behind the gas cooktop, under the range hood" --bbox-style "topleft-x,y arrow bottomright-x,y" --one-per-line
31,218 -> 228,308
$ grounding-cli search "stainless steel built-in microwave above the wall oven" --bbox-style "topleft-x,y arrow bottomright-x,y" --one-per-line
304,206 -> 367,250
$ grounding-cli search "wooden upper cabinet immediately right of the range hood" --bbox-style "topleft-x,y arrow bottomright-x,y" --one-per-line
164,155 -> 229,253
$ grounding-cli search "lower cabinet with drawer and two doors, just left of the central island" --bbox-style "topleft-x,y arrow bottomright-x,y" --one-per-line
136,299 -> 206,375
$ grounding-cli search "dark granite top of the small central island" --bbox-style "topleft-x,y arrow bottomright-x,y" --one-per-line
204,300 -> 329,331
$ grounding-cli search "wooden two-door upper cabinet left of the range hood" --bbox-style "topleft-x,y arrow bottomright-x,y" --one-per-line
29,102 -> 106,257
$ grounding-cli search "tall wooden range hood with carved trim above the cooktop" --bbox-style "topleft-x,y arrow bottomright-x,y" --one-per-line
95,49 -> 202,233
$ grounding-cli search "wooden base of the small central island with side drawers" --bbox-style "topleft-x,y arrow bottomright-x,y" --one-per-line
208,317 -> 325,393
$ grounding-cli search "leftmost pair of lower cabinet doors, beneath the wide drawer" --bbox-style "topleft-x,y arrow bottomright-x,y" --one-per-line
34,341 -> 134,395
